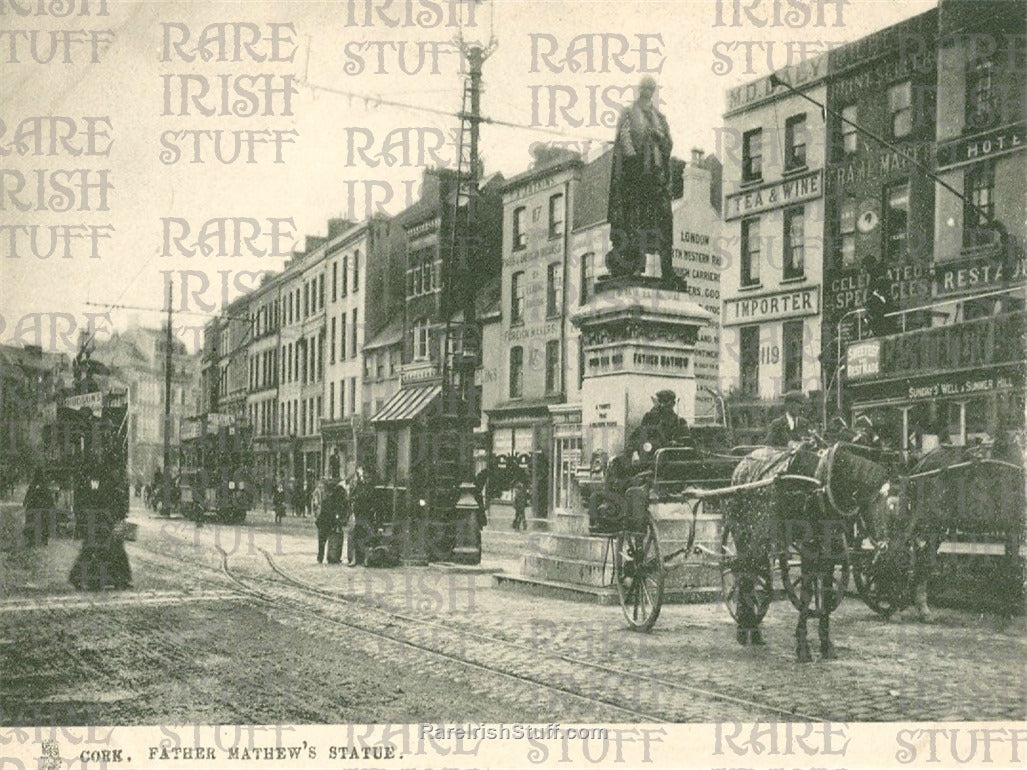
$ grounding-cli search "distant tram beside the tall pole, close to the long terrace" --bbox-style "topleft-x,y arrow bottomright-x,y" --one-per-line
176,414 -> 256,524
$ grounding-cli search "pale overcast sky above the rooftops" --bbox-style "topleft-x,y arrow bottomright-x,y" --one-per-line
0,0 -> 935,349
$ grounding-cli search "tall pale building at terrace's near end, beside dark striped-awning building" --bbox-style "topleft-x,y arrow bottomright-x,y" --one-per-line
321,218 -> 395,476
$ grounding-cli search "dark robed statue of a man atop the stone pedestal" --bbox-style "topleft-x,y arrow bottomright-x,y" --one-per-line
607,76 -> 678,287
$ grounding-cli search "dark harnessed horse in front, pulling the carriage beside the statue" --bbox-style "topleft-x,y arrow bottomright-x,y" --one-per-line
726,442 -> 888,662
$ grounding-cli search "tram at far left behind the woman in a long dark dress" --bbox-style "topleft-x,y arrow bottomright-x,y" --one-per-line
43,389 -> 129,538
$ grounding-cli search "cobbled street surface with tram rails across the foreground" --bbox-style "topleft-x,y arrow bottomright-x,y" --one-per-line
0,507 -> 1025,725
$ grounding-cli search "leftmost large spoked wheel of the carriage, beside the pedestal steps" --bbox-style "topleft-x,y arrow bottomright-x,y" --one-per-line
613,519 -> 667,631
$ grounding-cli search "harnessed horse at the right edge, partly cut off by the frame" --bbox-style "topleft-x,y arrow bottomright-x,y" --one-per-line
883,441 -> 1025,621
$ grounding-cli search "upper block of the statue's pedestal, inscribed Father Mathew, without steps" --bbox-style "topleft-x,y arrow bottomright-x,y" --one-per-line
571,276 -> 713,458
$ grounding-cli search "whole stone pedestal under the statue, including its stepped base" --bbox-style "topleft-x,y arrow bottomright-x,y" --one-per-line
496,276 -> 720,604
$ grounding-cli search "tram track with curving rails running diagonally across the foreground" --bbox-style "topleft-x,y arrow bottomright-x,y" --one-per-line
233,548 -> 824,722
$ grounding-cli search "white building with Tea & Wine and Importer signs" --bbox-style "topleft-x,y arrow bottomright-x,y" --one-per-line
719,56 -> 827,434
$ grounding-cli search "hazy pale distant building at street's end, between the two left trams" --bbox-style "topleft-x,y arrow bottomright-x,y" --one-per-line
92,329 -> 201,480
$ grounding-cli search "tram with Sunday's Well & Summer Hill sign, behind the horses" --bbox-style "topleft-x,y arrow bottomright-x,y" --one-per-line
845,311 -> 1027,454
